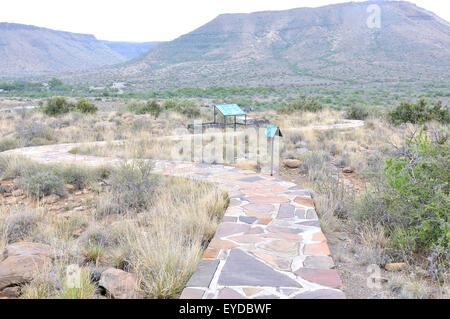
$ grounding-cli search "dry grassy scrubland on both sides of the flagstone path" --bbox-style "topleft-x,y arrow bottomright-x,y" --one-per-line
0,97 -> 449,298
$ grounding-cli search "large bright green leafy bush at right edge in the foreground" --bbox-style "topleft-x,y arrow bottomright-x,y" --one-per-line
360,130 -> 450,276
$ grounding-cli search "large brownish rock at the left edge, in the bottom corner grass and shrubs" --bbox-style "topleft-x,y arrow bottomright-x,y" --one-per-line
0,255 -> 51,290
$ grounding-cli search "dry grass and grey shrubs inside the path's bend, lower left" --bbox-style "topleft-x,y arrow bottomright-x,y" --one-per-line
0,156 -> 228,299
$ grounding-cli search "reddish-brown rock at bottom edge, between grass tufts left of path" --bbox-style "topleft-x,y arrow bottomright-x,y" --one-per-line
99,268 -> 142,299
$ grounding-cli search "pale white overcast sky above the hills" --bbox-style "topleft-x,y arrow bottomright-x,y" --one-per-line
0,0 -> 450,42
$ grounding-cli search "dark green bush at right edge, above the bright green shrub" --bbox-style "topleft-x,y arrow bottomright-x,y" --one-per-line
389,98 -> 450,124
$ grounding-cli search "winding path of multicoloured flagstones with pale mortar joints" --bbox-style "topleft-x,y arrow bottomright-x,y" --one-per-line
3,143 -> 345,299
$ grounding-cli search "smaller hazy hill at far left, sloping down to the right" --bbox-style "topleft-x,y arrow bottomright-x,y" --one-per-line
0,23 -> 126,78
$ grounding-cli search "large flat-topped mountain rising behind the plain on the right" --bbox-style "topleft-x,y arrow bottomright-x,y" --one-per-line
66,1 -> 450,88
